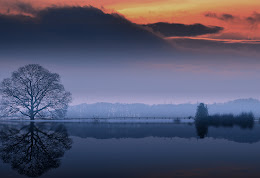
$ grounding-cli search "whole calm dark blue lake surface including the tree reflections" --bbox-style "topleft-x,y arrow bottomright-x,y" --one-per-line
0,122 -> 260,178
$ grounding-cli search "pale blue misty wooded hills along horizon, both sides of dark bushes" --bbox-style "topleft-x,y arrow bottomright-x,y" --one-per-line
67,98 -> 260,118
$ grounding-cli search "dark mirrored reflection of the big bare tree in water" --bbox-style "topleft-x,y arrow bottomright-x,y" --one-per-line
0,122 -> 72,177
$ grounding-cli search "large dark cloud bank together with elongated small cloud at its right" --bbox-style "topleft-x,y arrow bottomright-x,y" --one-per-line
0,3 -> 225,58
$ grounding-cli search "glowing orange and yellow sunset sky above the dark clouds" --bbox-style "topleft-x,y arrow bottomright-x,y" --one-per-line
0,0 -> 260,39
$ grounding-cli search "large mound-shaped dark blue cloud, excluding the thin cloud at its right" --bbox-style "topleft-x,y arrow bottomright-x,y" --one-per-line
0,6 -> 175,58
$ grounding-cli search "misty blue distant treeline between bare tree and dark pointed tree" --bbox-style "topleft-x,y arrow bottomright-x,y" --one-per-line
67,103 -> 196,118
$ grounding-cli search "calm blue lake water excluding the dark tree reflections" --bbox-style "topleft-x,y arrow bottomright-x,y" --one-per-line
0,123 -> 260,177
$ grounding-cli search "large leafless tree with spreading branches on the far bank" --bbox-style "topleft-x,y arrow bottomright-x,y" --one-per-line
0,64 -> 71,120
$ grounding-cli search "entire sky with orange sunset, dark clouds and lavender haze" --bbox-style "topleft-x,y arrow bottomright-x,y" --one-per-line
0,0 -> 260,104
